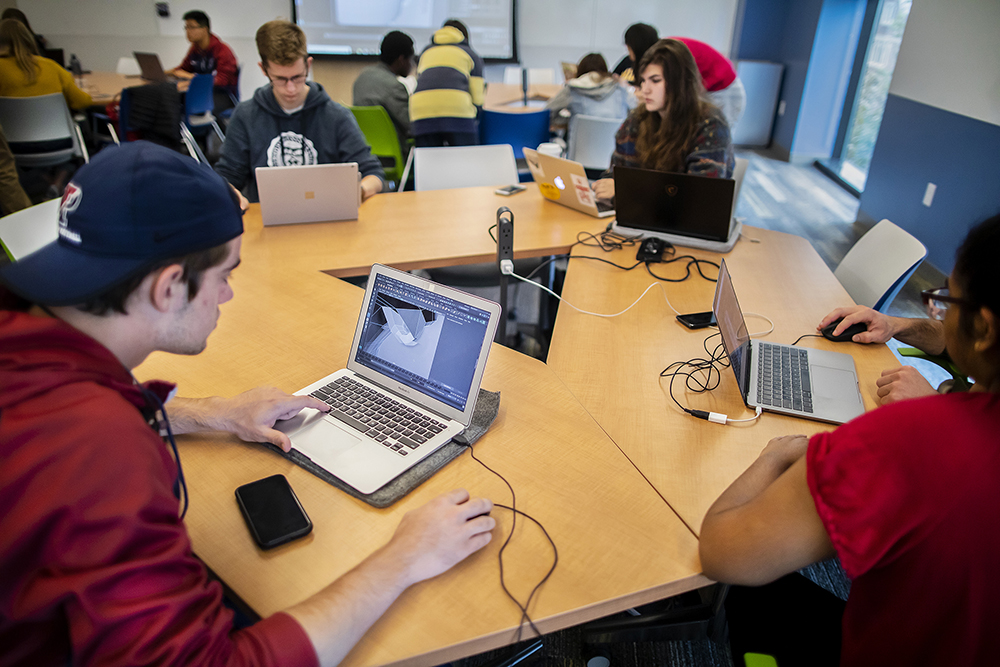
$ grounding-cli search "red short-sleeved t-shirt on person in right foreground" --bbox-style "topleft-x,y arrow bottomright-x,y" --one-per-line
806,393 -> 1000,667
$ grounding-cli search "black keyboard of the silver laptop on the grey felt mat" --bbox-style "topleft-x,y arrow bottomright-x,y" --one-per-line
310,377 -> 445,456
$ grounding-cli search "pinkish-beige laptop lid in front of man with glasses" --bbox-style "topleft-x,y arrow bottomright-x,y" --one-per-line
255,162 -> 361,227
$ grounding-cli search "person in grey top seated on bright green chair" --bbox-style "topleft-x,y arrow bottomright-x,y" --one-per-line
352,30 -> 416,159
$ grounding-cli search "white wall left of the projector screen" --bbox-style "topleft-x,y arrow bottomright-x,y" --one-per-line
17,0 -> 292,99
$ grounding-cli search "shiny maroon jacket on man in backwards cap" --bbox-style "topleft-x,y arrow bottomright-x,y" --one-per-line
0,310 -> 317,666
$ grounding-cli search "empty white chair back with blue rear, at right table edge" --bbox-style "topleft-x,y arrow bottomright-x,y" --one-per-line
833,220 -> 927,312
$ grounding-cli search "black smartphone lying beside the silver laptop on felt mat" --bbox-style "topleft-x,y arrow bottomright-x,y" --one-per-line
236,475 -> 312,549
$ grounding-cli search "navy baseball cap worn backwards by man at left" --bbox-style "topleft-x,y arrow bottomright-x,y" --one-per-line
0,141 -> 243,306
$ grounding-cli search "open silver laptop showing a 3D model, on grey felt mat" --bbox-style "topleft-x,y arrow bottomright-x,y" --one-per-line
275,264 -> 500,494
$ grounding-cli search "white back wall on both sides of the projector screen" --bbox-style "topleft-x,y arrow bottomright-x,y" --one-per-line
17,0 -> 738,99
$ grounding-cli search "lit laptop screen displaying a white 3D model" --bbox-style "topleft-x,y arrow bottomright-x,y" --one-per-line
354,274 -> 490,410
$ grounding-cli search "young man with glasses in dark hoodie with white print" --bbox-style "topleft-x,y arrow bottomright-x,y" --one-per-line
215,20 -> 385,202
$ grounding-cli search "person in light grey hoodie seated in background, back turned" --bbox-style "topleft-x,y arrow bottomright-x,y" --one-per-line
545,53 -> 635,134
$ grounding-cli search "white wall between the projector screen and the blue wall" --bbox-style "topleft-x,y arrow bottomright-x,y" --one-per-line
520,0 -> 737,80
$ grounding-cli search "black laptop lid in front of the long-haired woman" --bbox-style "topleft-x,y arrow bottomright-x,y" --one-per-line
615,167 -> 736,243
